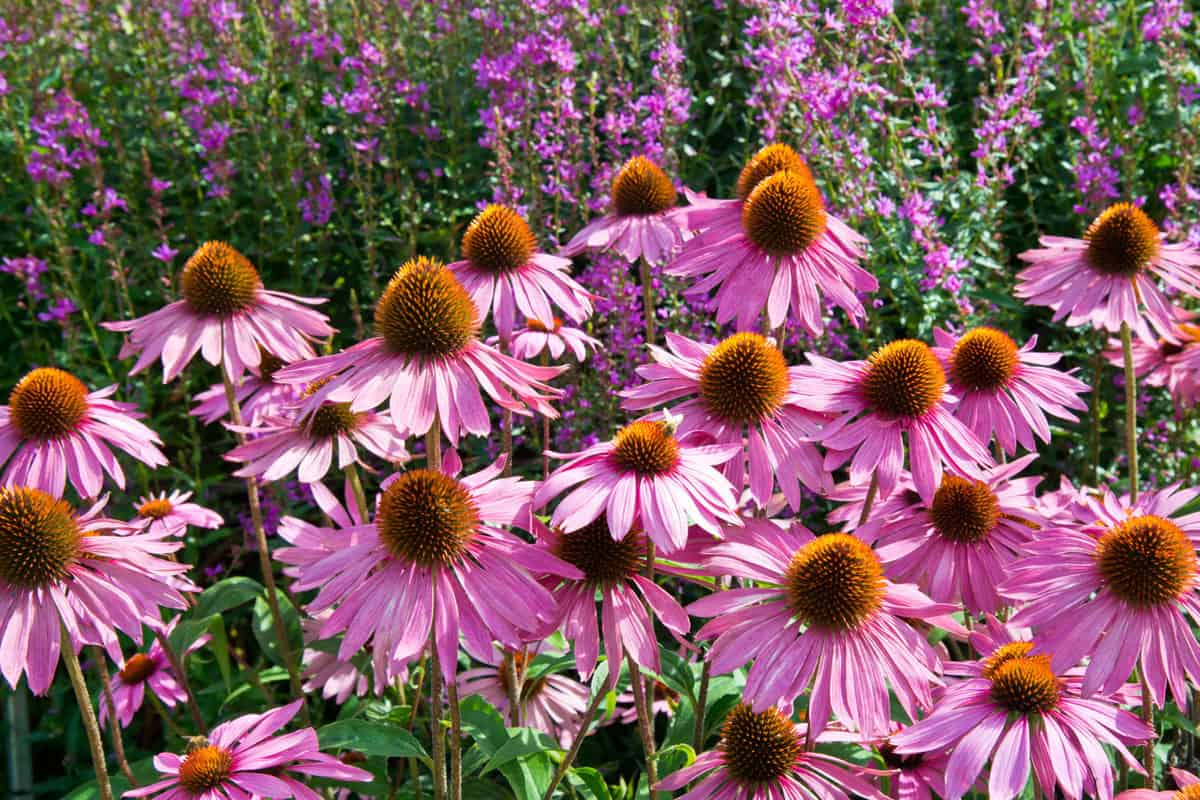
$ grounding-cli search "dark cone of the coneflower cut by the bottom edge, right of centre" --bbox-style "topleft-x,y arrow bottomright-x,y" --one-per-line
720,704 -> 800,786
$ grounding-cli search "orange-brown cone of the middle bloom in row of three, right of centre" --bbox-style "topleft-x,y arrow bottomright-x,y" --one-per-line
863,339 -> 946,416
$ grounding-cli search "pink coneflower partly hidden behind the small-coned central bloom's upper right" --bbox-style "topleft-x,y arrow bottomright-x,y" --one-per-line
622,333 -> 830,509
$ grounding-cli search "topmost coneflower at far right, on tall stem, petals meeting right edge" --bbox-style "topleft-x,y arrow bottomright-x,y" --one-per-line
1015,203 -> 1200,339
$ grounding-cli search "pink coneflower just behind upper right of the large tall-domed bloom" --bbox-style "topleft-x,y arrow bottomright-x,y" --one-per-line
446,204 -> 592,336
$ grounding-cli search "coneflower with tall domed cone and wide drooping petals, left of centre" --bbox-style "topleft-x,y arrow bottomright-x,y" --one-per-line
275,258 -> 562,443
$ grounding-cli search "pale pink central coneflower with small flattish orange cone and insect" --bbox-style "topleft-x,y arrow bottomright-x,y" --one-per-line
534,420 -> 742,553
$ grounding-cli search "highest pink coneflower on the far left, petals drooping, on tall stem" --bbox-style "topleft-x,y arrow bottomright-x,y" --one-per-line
104,241 -> 334,383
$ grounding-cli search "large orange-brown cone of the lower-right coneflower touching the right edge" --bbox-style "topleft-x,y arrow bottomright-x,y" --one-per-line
1096,515 -> 1196,608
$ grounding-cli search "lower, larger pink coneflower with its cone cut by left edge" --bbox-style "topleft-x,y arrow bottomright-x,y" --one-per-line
0,486 -> 187,694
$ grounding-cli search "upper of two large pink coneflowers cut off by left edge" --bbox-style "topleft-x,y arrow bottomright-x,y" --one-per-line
0,367 -> 167,498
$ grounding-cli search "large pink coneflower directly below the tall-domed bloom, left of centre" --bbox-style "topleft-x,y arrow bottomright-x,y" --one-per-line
276,450 -> 581,682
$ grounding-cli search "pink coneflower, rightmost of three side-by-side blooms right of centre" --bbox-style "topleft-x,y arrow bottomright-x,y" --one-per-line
934,327 -> 1088,455
